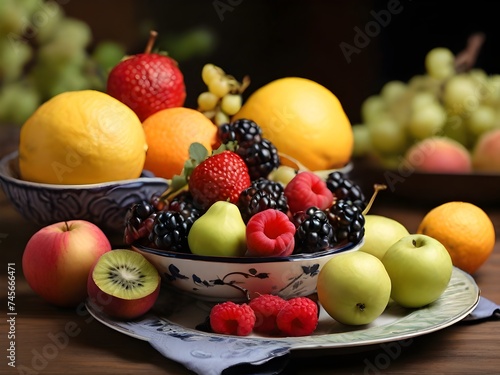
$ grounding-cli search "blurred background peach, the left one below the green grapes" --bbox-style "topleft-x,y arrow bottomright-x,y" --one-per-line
405,137 -> 472,173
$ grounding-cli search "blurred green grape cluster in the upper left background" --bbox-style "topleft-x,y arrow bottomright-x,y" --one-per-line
0,0 -> 124,124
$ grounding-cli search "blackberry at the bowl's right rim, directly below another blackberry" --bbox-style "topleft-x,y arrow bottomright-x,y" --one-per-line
328,199 -> 365,243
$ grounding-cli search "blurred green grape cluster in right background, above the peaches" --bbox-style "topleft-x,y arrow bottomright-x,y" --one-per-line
353,43 -> 500,168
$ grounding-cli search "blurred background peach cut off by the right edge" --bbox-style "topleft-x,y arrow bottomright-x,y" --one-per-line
472,129 -> 500,173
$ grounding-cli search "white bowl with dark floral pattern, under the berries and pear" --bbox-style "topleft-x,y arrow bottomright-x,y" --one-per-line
133,242 -> 362,301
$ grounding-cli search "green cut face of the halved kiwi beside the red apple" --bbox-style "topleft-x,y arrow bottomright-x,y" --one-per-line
92,249 -> 160,300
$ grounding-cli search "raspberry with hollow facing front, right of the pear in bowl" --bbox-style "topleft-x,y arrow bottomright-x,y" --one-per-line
246,208 -> 295,256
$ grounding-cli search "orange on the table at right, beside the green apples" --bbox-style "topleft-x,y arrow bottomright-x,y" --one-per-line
417,202 -> 495,274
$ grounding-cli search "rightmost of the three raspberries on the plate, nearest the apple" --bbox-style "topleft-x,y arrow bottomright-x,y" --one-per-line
276,297 -> 318,336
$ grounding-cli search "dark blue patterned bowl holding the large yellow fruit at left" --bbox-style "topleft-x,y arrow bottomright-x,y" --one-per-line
0,151 -> 168,233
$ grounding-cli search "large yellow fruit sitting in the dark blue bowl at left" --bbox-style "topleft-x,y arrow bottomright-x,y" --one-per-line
19,90 -> 147,185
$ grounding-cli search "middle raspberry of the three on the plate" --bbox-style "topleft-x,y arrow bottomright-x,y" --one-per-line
248,294 -> 286,334
